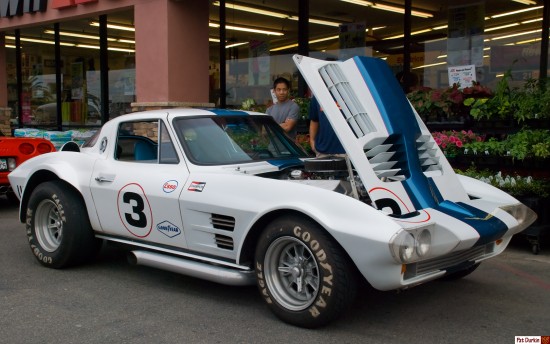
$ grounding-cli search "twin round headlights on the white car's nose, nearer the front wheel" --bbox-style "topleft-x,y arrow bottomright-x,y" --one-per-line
390,228 -> 432,263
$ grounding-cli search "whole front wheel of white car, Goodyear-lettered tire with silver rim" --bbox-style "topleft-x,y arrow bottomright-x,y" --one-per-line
255,215 -> 357,328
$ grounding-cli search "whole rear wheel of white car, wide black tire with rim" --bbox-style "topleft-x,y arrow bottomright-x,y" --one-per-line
26,181 -> 101,269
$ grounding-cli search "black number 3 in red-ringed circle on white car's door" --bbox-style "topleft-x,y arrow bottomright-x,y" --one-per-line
117,183 -> 153,238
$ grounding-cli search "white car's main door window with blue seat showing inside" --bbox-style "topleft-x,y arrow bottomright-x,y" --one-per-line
115,120 -> 159,163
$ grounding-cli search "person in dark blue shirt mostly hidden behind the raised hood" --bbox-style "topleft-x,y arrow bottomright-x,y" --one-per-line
309,97 -> 346,158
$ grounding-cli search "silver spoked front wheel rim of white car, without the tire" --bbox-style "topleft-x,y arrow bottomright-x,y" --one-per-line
264,236 -> 319,311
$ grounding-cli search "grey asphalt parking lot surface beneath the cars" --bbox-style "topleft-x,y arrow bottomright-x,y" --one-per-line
0,197 -> 550,343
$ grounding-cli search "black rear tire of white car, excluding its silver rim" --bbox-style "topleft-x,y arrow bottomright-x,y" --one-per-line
25,182 -> 83,268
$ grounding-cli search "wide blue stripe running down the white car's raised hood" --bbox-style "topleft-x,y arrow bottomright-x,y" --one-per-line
353,56 -> 440,209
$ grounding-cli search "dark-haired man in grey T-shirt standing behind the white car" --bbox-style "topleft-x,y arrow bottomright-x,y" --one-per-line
267,78 -> 300,140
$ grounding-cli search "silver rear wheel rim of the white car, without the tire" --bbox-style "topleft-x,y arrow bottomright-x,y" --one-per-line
35,199 -> 63,252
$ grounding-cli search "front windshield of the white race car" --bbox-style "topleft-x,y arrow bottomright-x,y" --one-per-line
174,115 -> 307,164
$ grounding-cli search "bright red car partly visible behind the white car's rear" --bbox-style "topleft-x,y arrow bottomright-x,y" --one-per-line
0,132 -> 55,202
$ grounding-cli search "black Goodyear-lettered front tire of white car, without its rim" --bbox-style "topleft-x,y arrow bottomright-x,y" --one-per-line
255,218 -> 352,328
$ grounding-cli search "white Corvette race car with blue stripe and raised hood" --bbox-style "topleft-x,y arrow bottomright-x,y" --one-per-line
9,55 -> 536,328
